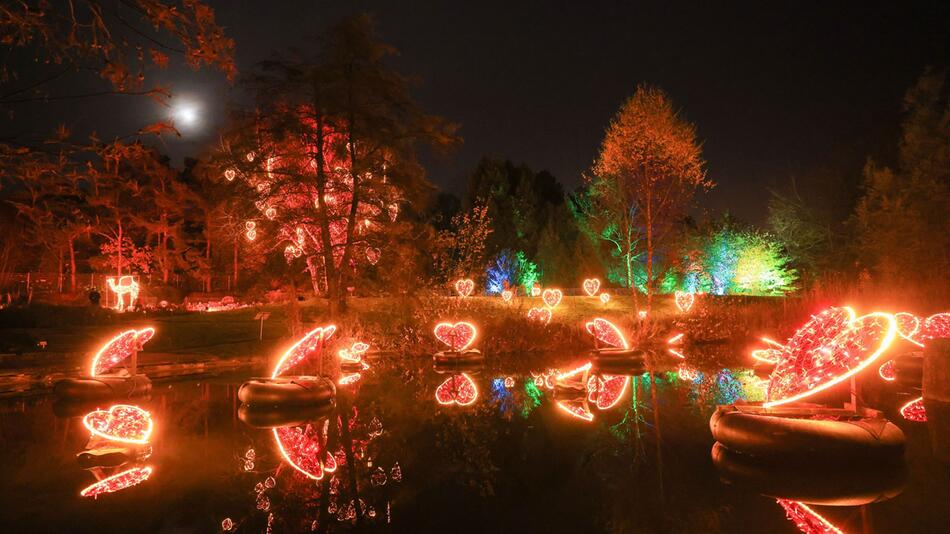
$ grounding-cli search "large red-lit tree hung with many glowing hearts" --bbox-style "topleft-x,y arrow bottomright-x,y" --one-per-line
221,16 -> 456,313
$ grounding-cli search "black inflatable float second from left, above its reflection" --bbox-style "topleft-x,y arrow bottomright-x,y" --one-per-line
238,376 -> 336,406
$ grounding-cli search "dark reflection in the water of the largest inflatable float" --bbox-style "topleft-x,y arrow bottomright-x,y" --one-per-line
711,443 -> 907,506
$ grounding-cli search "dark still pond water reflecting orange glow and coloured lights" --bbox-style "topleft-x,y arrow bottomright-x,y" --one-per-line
0,355 -> 950,533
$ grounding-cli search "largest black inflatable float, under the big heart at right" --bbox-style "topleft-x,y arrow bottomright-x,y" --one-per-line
709,405 -> 904,462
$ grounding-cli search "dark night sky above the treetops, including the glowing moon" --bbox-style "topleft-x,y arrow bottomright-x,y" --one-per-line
9,0 -> 950,222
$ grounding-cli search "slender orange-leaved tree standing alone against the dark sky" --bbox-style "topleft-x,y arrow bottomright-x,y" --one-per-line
587,86 -> 713,306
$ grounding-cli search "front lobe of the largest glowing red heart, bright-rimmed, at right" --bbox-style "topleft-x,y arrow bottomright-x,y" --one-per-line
764,312 -> 897,408
